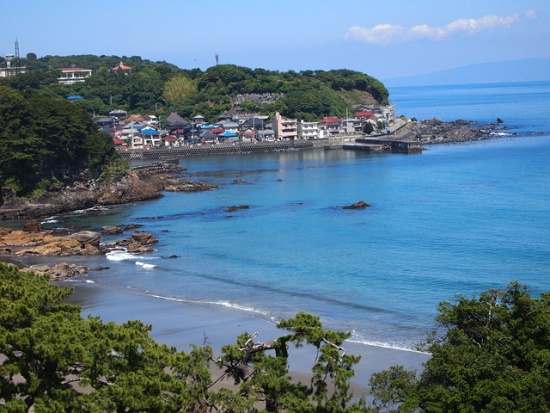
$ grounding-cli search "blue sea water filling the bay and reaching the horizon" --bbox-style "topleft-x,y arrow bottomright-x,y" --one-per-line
32,82 -> 550,348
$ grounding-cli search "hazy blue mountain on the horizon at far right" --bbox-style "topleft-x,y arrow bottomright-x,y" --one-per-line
382,59 -> 550,87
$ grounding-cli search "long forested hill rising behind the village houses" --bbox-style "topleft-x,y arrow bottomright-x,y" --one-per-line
0,53 -> 389,120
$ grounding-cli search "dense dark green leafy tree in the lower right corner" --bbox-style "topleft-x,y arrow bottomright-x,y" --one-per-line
376,282 -> 550,413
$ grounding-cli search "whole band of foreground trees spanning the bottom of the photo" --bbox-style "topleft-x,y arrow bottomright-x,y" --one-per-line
0,264 -> 550,413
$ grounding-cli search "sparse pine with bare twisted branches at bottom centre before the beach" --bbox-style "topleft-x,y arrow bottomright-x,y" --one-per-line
218,313 -> 365,412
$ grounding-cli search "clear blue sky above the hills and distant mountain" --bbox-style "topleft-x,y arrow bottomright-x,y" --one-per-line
0,0 -> 550,80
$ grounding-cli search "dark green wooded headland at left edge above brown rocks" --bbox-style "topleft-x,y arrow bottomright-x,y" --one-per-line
0,86 -> 118,196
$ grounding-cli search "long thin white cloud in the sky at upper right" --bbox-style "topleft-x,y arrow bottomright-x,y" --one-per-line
346,11 -> 536,45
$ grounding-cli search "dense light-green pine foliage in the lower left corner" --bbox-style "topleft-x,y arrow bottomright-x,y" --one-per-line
0,264 -> 216,412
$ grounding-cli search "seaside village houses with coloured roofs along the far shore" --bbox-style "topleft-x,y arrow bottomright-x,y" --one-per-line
96,106 -> 395,149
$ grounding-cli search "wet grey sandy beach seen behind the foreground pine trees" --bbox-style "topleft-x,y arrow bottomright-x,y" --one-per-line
60,280 -> 429,389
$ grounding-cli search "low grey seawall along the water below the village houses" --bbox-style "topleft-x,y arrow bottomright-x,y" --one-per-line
120,140 -> 315,160
